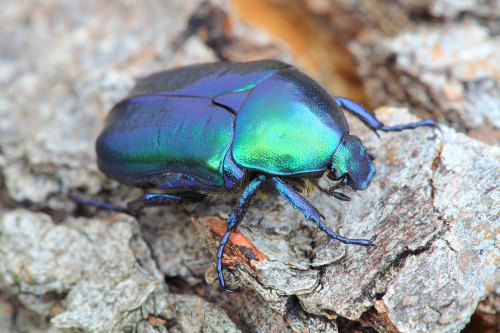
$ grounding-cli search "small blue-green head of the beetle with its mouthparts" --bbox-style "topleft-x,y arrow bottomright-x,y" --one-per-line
328,135 -> 375,200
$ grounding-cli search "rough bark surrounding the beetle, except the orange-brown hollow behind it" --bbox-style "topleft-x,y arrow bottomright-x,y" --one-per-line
0,0 -> 500,332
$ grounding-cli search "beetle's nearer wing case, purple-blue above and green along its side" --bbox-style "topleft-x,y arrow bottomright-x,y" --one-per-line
96,94 -> 234,188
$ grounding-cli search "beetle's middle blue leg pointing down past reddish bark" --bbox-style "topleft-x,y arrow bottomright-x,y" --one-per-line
217,175 -> 266,292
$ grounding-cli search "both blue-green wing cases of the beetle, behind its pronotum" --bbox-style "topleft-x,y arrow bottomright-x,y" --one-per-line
96,60 -> 290,189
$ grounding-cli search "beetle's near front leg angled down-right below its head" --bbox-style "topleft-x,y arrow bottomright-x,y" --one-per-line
271,177 -> 375,246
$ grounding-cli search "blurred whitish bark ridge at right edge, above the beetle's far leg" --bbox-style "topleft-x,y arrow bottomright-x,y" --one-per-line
352,21 -> 500,130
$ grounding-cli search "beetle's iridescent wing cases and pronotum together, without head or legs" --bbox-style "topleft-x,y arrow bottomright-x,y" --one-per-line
96,61 -> 349,190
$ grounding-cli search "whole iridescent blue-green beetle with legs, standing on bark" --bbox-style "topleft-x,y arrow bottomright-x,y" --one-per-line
91,60 -> 439,292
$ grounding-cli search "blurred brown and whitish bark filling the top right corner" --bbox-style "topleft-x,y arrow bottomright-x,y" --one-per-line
296,0 -> 500,144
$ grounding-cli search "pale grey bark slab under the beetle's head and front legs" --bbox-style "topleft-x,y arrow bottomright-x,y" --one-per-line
206,108 -> 500,332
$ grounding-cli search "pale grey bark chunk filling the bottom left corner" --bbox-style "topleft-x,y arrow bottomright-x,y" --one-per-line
0,210 -> 240,332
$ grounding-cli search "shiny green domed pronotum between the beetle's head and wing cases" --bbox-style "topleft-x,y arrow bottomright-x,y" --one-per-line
232,68 -> 349,175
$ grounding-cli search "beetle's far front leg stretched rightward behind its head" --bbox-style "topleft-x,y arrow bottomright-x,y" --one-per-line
334,97 -> 441,136
